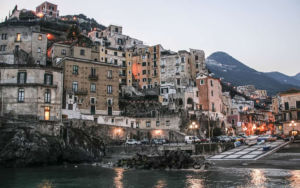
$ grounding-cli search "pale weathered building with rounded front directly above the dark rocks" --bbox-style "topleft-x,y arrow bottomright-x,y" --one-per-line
0,64 -> 62,121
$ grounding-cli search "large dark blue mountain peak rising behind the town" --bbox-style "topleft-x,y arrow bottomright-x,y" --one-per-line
205,52 -> 299,96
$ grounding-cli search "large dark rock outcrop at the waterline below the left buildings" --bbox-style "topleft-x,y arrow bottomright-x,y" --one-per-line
0,127 -> 105,167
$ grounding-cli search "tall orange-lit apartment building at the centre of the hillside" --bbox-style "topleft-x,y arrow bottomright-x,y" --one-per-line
132,45 -> 164,89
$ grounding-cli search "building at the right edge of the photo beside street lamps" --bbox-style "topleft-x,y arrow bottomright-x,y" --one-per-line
276,89 -> 300,135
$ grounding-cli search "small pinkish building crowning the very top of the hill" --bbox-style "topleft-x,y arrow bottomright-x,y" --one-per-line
36,1 -> 59,18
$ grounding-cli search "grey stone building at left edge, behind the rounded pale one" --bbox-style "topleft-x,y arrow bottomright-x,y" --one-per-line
0,23 -> 47,65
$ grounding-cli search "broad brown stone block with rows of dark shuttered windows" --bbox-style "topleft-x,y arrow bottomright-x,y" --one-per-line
57,56 -> 120,118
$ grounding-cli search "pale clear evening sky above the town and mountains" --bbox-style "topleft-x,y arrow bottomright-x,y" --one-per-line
0,0 -> 300,76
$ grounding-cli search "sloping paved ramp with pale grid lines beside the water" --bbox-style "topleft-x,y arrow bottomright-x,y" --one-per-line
208,140 -> 287,160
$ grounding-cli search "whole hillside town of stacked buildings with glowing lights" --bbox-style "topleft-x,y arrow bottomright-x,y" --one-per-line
0,2 -> 300,142
